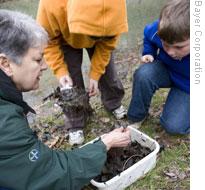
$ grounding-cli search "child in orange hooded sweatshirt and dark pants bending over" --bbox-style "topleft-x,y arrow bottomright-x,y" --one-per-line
37,0 -> 128,145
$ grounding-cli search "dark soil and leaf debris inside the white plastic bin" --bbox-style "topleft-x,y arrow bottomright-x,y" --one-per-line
94,141 -> 152,182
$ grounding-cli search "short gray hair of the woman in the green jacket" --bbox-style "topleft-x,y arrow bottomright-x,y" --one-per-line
0,10 -> 48,64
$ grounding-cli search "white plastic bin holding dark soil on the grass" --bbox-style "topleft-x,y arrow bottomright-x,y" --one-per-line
89,126 -> 160,190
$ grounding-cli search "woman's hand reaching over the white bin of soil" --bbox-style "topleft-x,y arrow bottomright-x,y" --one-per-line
101,127 -> 131,150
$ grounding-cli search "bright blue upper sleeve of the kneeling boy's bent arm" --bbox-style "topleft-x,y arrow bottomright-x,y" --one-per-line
142,21 -> 158,58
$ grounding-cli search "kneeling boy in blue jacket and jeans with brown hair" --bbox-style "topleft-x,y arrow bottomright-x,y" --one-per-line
128,0 -> 190,134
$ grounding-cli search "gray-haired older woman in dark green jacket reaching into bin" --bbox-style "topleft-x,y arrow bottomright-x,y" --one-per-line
0,10 -> 130,190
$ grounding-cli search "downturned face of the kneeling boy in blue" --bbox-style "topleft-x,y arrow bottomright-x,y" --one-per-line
162,39 -> 190,60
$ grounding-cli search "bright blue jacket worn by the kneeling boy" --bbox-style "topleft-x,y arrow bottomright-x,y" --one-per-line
143,21 -> 190,93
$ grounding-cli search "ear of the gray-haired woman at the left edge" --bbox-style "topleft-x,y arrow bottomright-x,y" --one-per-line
0,53 -> 13,77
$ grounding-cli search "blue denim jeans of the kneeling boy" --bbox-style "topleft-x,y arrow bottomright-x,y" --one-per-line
128,61 -> 190,134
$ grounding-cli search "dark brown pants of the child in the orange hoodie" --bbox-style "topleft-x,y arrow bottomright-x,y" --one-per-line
62,45 -> 124,128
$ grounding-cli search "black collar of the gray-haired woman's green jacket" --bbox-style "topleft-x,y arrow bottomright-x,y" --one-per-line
0,69 -> 35,114
